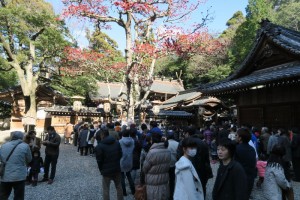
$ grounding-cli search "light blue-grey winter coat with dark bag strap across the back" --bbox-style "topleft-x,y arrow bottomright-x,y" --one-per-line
0,139 -> 32,182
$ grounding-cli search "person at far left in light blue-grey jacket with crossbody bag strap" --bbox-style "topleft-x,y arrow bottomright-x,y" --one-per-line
0,131 -> 32,199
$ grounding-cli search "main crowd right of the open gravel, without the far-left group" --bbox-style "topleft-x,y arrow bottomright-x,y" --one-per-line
67,121 -> 300,200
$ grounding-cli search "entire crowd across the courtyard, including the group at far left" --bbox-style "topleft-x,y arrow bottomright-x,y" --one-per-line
0,121 -> 300,200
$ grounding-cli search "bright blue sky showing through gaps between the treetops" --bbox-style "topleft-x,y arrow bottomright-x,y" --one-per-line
46,0 -> 248,51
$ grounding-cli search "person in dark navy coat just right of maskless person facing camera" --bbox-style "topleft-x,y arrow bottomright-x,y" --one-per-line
234,128 -> 257,198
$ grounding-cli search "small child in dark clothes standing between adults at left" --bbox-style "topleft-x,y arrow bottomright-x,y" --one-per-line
29,150 -> 44,187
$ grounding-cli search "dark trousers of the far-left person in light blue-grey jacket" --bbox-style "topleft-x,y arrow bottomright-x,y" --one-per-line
0,180 -> 25,200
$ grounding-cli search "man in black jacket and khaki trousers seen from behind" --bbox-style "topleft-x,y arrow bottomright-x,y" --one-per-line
95,129 -> 123,200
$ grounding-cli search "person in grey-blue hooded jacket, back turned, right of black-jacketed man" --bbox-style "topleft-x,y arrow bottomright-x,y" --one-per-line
119,130 -> 135,196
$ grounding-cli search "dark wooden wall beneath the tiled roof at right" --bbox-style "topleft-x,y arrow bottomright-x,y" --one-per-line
237,85 -> 300,128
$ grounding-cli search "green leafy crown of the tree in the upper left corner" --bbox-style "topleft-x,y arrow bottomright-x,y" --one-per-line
0,0 -> 70,77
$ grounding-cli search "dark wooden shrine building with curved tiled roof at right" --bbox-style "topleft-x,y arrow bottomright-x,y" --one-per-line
198,20 -> 300,128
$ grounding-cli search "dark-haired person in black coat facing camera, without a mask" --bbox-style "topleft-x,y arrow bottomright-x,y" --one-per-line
212,138 -> 249,200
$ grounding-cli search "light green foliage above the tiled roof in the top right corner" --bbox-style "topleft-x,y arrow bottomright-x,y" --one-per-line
275,1 -> 300,31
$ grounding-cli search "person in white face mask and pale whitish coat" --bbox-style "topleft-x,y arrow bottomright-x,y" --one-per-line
173,137 -> 204,200
